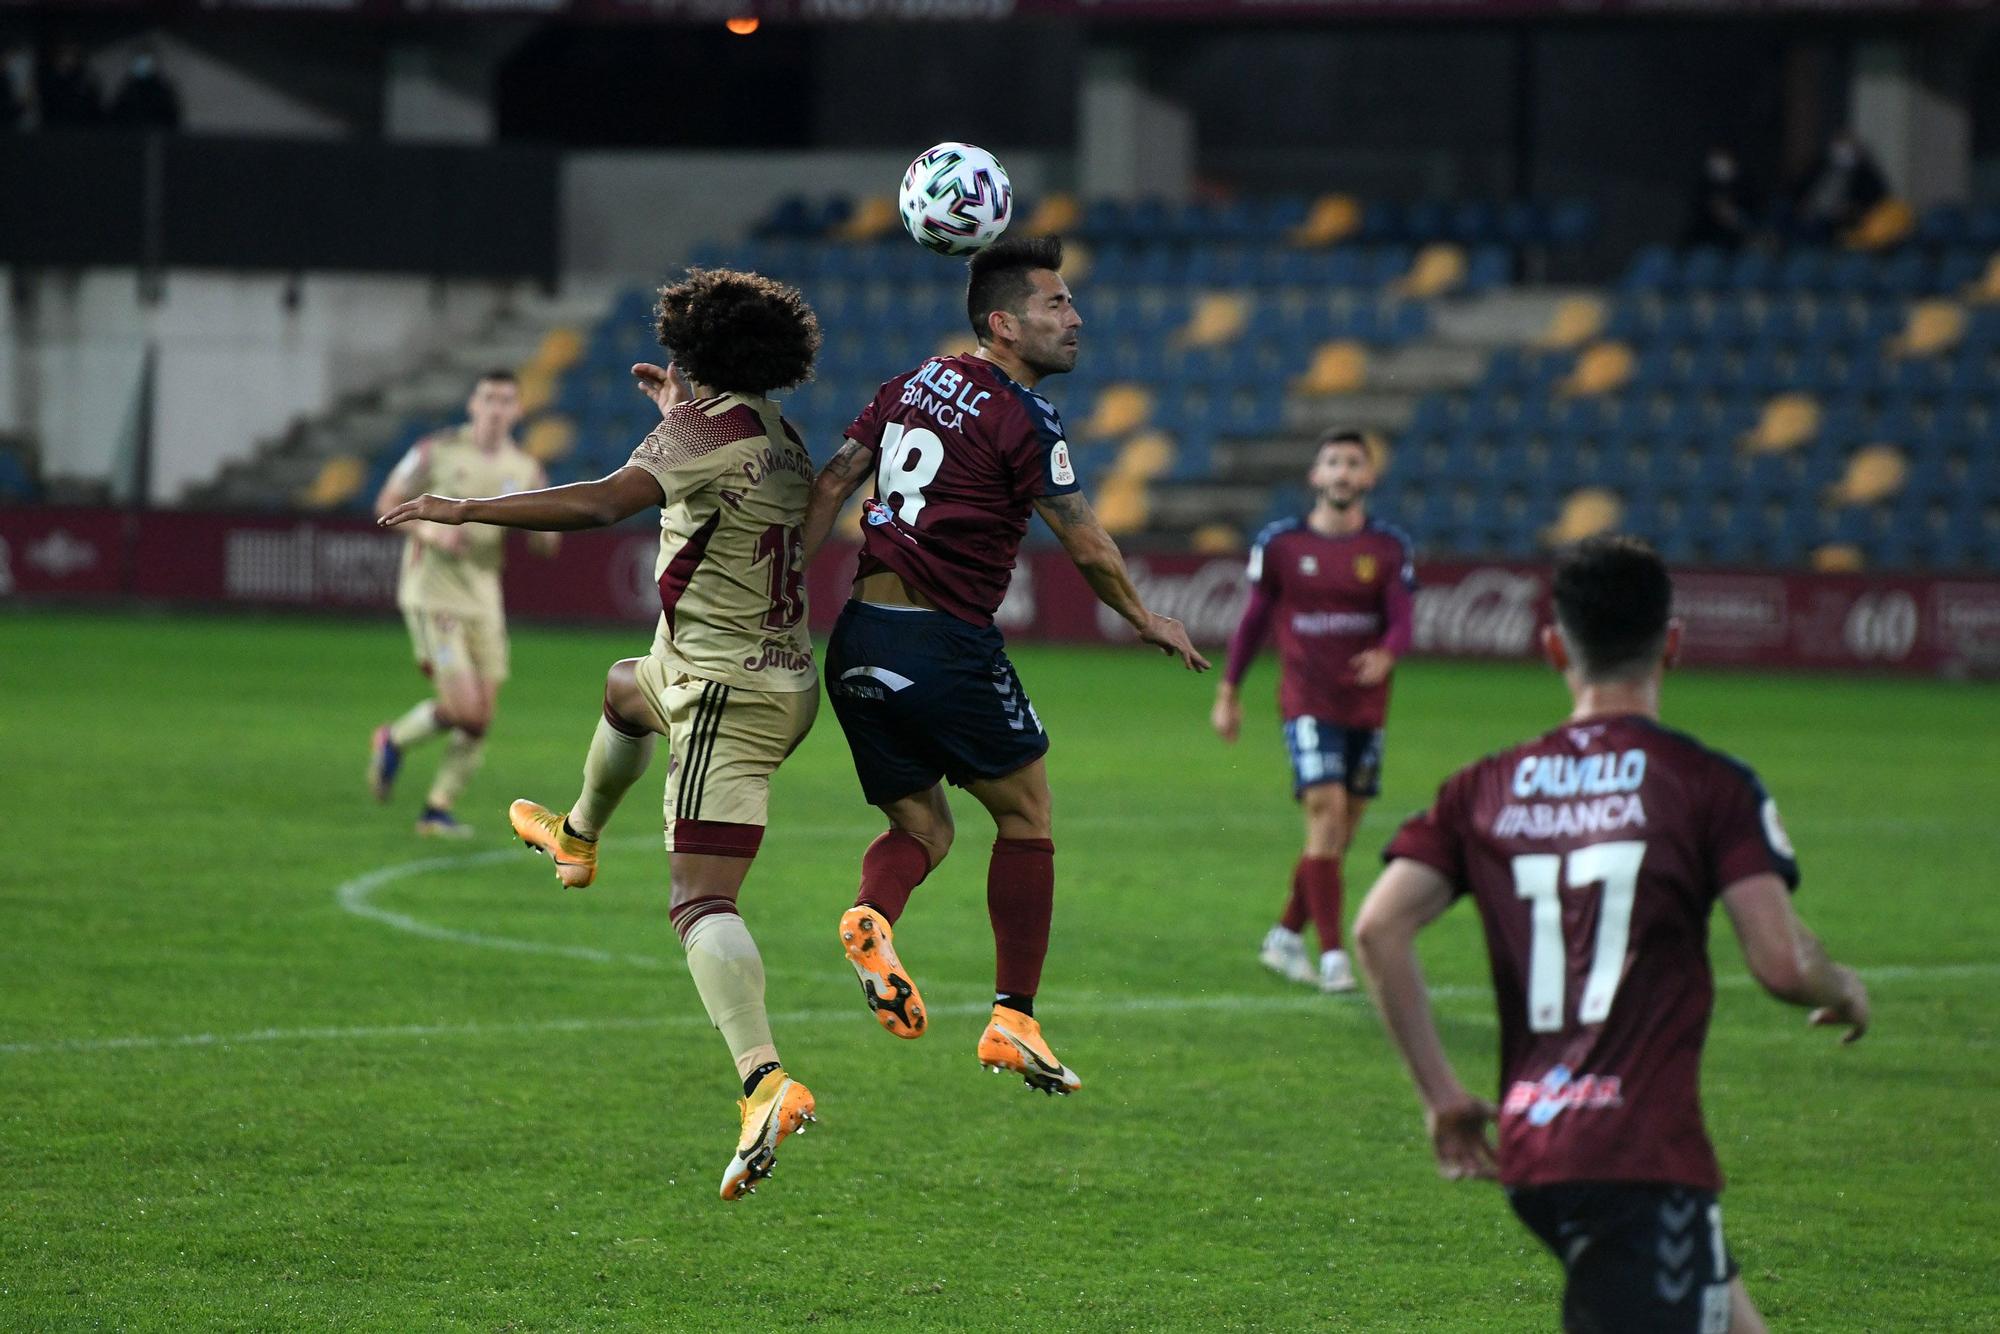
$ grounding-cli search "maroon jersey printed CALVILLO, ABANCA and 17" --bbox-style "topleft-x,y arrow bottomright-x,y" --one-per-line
1382,716 -> 1798,1190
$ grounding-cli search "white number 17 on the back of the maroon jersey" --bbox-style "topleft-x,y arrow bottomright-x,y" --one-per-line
1514,840 -> 1646,1032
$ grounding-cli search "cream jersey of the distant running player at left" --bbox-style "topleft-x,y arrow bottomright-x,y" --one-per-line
394,426 -> 548,616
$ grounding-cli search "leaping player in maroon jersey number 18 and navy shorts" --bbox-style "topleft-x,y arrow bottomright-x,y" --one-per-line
804,238 -> 1208,1094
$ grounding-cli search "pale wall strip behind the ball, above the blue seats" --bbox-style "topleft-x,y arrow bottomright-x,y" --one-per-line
562,144 -> 1060,280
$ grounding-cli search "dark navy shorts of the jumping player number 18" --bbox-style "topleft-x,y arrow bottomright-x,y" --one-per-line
826,602 -> 1048,806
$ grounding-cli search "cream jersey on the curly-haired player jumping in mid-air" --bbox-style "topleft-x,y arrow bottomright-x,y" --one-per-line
630,394 -> 818,692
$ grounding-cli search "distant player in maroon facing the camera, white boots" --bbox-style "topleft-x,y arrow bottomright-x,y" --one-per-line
1208,430 -> 1416,992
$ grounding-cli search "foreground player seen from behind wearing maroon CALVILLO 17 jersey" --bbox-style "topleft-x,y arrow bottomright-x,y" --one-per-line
1354,538 -> 1868,1334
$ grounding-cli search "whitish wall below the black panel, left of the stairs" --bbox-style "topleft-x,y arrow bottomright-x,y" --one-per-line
0,270 -> 510,502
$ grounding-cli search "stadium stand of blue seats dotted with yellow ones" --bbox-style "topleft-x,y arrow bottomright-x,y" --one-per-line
320,196 -> 2000,570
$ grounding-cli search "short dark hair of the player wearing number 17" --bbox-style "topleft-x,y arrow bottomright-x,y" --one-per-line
1550,534 -> 1674,680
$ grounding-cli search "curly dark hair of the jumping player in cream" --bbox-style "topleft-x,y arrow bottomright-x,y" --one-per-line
654,268 -> 820,394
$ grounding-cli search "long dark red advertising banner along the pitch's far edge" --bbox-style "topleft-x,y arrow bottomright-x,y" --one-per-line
0,510 -> 2000,676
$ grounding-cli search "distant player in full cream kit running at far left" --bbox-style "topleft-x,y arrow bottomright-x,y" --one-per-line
368,370 -> 560,838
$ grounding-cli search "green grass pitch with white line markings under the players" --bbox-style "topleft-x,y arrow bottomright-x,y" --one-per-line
0,612 -> 2000,1330
